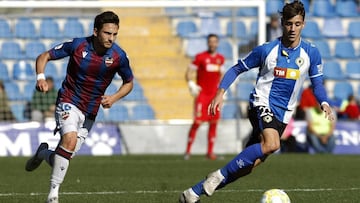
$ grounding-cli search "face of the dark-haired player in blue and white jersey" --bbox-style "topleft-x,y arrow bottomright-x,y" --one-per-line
282,15 -> 305,47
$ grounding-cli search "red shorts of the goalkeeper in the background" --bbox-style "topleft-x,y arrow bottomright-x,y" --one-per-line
194,93 -> 220,121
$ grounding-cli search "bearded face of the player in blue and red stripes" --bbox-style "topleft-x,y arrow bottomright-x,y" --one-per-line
94,23 -> 119,49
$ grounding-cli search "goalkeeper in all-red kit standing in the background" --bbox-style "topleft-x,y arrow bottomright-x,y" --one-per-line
184,34 -> 225,160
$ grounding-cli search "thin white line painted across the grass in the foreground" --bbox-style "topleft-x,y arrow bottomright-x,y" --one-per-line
0,188 -> 360,197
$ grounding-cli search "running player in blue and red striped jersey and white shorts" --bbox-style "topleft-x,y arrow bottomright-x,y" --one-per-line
25,11 -> 133,203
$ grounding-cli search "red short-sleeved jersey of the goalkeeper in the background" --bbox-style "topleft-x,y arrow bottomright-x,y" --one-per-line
191,51 -> 225,95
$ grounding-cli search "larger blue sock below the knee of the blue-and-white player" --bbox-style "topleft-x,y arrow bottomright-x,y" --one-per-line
220,143 -> 264,179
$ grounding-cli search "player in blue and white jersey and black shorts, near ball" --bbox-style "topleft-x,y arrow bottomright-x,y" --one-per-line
179,0 -> 334,203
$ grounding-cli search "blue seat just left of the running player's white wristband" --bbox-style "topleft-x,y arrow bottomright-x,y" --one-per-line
12,61 -> 35,80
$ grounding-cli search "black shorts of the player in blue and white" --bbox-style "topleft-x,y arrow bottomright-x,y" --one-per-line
246,106 -> 286,146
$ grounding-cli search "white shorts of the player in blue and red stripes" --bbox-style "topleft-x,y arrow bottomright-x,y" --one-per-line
55,103 -> 94,139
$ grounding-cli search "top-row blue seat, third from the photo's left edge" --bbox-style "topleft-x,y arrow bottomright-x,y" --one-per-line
40,18 -> 62,39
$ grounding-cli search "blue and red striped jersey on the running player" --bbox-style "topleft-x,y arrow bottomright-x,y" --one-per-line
49,36 -> 133,118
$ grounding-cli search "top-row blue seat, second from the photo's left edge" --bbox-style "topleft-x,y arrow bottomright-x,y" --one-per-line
15,17 -> 38,39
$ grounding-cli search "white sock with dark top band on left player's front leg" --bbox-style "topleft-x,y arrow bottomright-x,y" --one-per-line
48,146 -> 72,198
